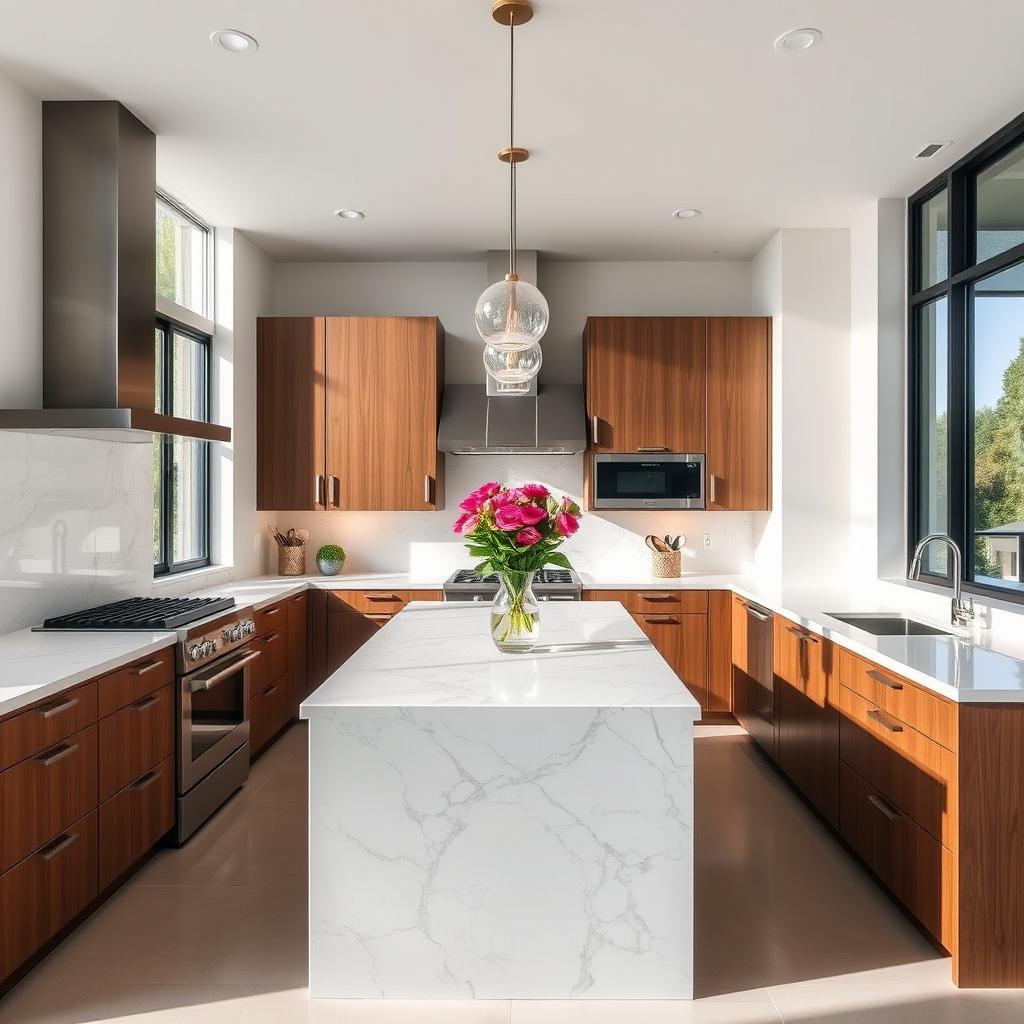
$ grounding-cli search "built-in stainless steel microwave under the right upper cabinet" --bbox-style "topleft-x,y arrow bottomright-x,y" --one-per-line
592,452 -> 705,509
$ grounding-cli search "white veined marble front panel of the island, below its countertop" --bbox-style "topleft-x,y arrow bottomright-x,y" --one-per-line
309,707 -> 693,998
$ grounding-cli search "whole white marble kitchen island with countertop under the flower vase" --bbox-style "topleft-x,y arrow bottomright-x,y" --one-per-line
301,602 -> 700,999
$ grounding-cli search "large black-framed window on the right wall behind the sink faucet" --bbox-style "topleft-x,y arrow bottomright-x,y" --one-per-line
907,115 -> 1024,602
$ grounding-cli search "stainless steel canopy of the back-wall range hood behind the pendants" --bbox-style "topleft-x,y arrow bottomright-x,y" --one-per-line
437,382 -> 587,455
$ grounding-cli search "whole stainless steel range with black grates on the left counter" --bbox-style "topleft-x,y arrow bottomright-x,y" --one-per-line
41,597 -> 260,844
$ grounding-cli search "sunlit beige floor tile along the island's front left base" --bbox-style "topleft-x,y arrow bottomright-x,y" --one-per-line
239,988 -> 509,1024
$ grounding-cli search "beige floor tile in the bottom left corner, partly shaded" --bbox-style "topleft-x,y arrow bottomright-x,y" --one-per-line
0,981 -> 251,1024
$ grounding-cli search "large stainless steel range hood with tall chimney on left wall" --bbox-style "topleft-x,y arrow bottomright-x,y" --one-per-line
0,100 -> 231,442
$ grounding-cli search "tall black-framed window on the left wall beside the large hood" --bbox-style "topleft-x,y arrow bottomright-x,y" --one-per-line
153,193 -> 213,575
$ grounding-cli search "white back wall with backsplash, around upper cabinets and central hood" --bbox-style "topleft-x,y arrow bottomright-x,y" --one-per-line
261,257 -> 754,577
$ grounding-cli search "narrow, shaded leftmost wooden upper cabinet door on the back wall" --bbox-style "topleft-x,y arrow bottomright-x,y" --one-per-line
256,316 -> 326,511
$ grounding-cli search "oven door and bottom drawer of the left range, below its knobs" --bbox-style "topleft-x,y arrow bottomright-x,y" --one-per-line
176,646 -> 260,843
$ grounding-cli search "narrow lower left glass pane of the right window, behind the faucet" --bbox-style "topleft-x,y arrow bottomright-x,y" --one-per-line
916,296 -> 949,575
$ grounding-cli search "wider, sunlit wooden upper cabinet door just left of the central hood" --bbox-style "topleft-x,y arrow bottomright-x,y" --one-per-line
327,316 -> 444,512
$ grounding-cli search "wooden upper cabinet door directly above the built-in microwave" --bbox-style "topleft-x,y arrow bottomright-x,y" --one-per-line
584,316 -> 707,452
